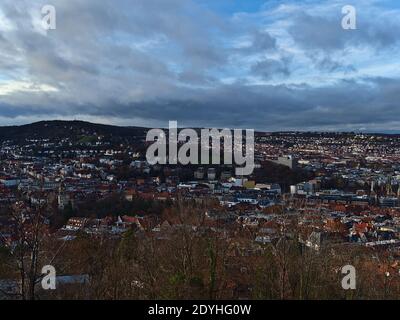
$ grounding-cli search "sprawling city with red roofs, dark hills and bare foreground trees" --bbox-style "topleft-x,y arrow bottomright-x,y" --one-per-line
0,121 -> 400,299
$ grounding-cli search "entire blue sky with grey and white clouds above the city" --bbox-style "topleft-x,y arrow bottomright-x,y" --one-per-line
0,0 -> 400,132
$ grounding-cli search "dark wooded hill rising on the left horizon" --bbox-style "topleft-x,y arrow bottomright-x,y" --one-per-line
0,120 -> 147,140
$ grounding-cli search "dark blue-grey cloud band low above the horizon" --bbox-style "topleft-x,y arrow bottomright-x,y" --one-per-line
1,78 -> 392,130
